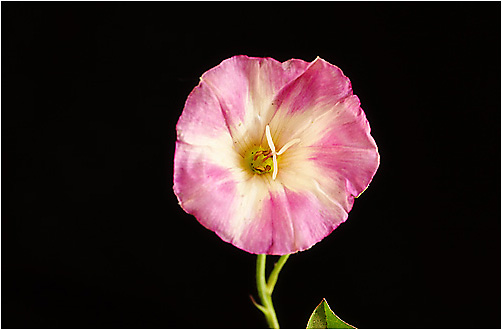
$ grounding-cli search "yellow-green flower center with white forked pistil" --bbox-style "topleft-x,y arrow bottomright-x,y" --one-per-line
245,125 -> 300,180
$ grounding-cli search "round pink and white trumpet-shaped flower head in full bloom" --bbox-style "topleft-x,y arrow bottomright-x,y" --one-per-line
174,56 -> 380,255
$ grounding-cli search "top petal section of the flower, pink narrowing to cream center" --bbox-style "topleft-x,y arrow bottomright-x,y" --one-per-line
201,56 -> 309,153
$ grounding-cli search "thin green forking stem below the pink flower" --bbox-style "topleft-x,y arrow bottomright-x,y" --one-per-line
253,254 -> 289,329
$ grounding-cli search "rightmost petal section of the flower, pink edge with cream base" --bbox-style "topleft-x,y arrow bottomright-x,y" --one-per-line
272,95 -> 380,217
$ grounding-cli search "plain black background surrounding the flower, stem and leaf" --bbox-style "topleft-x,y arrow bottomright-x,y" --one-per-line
1,2 -> 501,328
